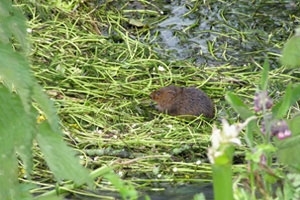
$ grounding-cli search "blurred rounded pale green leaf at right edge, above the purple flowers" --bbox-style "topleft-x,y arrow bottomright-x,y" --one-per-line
281,28 -> 300,68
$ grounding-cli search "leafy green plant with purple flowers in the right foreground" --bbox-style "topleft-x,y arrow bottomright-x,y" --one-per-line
220,57 -> 300,200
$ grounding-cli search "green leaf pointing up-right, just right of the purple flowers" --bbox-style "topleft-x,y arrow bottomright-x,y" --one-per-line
272,84 -> 300,119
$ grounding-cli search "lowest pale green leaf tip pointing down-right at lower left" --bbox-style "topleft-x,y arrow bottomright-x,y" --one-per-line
37,121 -> 92,185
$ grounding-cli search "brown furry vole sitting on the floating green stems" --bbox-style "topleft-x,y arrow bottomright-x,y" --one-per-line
150,85 -> 215,118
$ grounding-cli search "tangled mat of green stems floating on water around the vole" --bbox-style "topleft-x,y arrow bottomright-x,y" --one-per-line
15,0 -> 300,199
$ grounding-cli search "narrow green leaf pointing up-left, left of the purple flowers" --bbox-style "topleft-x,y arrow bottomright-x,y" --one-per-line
225,92 -> 254,120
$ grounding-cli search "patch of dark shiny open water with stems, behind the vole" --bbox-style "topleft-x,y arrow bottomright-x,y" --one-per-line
156,0 -> 299,65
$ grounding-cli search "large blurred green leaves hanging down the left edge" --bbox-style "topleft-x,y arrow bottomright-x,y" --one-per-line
0,1 -> 91,200
